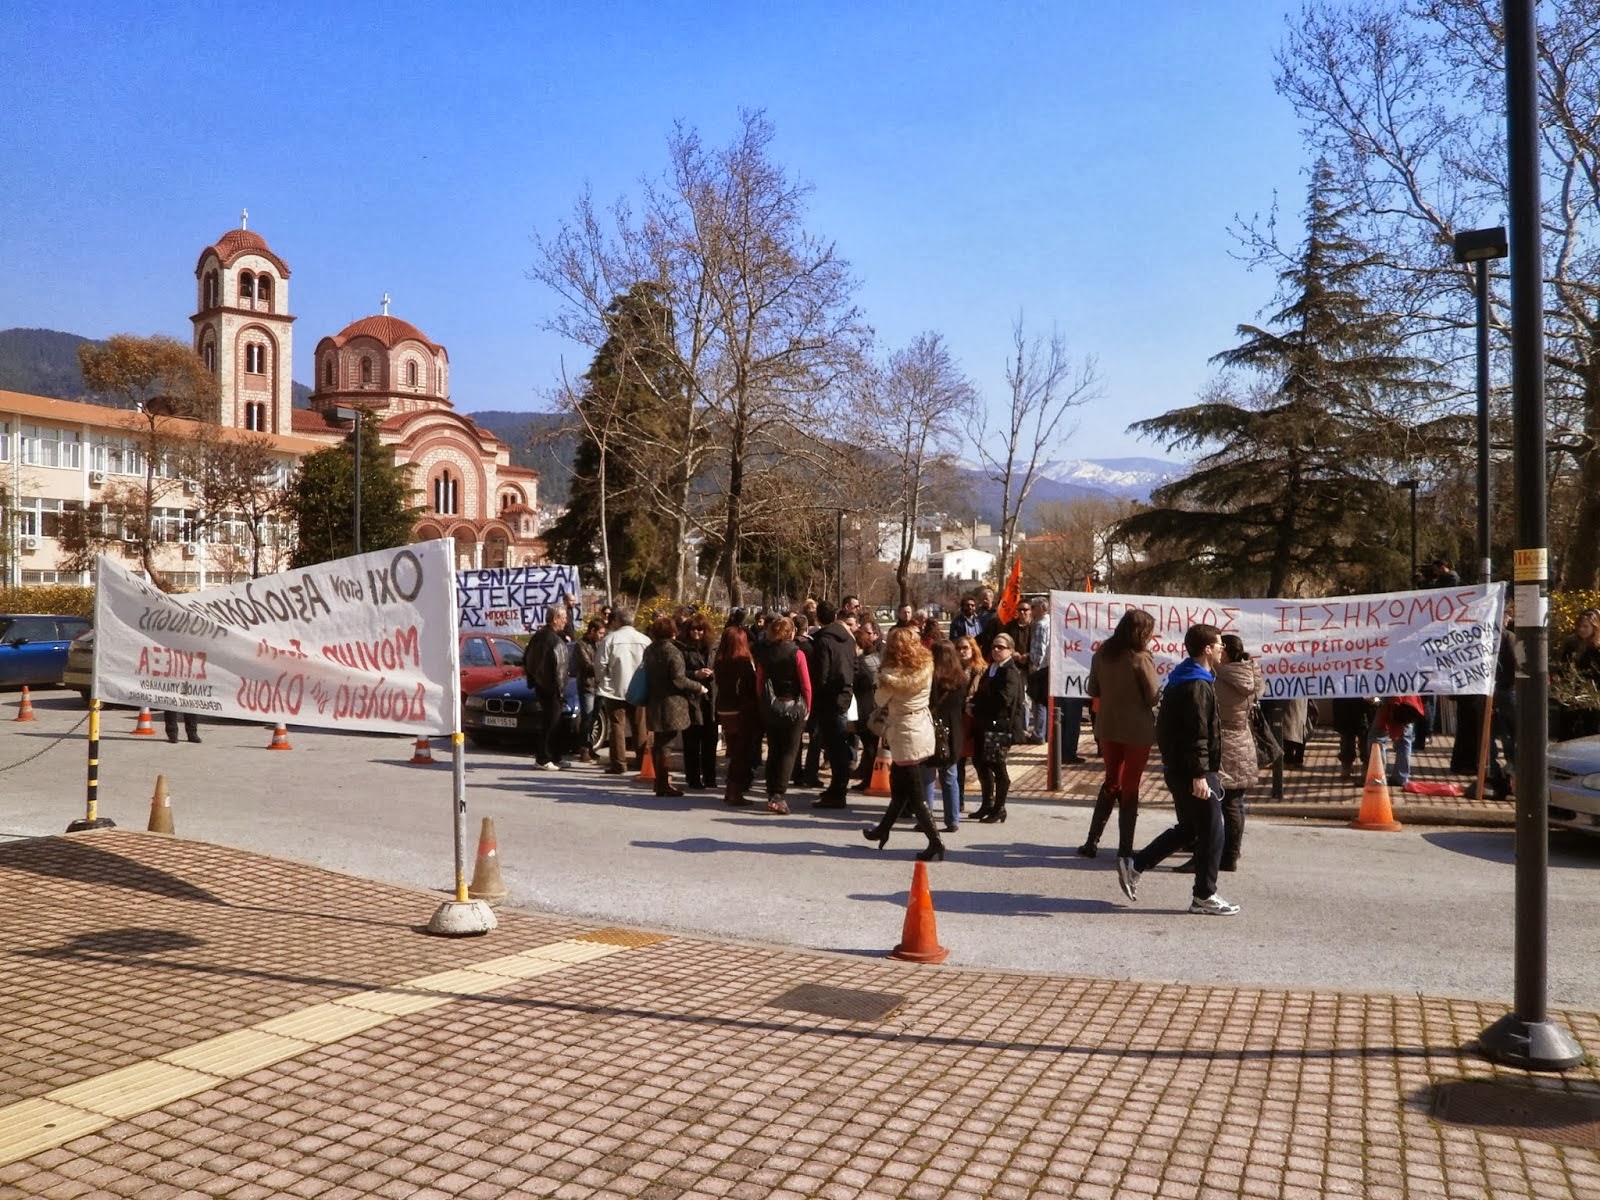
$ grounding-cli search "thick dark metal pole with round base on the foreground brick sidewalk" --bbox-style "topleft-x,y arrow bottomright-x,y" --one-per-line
1478,0 -> 1584,1070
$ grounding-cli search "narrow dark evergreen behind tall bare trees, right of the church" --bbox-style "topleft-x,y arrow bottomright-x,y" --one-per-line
544,283 -> 688,595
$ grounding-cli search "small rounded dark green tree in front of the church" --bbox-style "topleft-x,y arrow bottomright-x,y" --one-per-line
288,413 -> 422,566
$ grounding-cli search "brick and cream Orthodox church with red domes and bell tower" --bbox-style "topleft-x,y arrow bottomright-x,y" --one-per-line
190,219 -> 544,568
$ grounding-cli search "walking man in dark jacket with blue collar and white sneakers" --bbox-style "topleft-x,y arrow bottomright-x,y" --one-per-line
1117,626 -> 1238,917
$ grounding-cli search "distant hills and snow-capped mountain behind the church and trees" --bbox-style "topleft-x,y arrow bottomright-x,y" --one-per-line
0,330 -> 1182,526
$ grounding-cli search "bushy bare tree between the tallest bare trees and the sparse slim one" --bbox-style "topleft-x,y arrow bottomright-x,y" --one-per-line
862,333 -> 978,605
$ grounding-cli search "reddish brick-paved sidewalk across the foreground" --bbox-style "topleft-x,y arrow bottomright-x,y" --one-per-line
0,830 -> 1600,1200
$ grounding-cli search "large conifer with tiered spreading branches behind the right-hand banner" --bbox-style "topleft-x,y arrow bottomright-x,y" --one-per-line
1120,163 -> 1434,595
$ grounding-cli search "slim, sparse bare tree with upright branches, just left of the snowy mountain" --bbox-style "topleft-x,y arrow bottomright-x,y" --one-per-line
978,317 -> 1101,578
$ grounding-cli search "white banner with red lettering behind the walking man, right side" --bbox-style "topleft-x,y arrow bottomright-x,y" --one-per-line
1050,584 -> 1506,699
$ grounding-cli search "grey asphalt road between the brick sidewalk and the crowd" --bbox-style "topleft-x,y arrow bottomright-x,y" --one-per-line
0,693 -> 1600,1010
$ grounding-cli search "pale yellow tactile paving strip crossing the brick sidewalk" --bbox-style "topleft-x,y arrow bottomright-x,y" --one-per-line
0,930 -> 662,1166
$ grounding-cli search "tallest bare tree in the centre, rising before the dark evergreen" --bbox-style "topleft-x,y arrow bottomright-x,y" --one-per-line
531,112 -> 869,603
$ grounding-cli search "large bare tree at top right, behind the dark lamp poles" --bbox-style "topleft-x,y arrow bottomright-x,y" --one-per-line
1277,0 -> 1600,587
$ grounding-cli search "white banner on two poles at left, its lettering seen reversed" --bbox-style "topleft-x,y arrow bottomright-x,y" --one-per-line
94,538 -> 461,736
